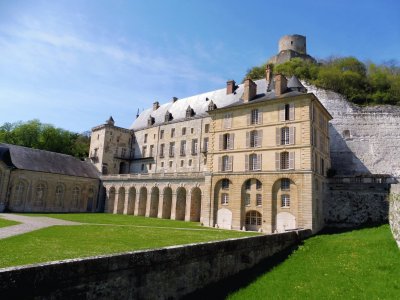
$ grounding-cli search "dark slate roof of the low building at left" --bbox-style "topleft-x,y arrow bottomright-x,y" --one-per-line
0,143 -> 100,178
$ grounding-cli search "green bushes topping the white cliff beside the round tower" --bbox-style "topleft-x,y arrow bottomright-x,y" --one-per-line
245,57 -> 400,105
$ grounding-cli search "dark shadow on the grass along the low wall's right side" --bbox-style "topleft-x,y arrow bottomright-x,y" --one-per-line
182,242 -> 302,300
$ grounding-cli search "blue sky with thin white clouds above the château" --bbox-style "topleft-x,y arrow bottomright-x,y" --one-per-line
0,0 -> 400,132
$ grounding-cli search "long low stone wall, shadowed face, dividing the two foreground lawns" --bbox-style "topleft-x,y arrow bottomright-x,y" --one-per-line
0,230 -> 310,299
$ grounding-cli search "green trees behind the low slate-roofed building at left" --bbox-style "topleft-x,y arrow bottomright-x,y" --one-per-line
0,120 -> 90,158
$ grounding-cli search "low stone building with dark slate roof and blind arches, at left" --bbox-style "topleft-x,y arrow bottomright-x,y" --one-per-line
0,144 -> 103,212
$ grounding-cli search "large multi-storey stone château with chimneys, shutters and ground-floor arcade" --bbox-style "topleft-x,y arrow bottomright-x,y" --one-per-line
90,70 -> 331,233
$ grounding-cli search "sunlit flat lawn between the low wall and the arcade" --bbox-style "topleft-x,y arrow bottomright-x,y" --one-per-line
0,214 -> 257,268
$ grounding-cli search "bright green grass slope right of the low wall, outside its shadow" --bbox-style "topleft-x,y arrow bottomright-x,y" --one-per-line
229,225 -> 400,299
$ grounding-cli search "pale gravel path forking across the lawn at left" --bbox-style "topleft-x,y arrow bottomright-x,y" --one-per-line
0,213 -> 81,239
